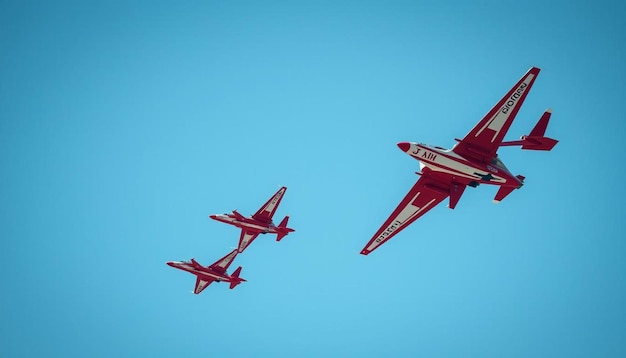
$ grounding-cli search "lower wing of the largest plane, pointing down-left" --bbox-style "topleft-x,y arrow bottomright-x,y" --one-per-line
361,173 -> 450,255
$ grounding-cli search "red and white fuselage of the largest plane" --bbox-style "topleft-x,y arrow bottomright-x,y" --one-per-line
398,142 -> 523,188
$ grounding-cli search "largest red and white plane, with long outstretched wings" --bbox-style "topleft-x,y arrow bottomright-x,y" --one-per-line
361,67 -> 558,255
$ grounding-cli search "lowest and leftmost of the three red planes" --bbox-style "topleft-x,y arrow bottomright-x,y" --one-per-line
167,249 -> 246,294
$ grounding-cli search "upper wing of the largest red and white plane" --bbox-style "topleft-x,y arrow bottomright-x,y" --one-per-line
452,67 -> 540,161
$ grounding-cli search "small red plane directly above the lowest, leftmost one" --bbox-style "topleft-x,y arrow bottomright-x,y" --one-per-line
209,187 -> 295,252
